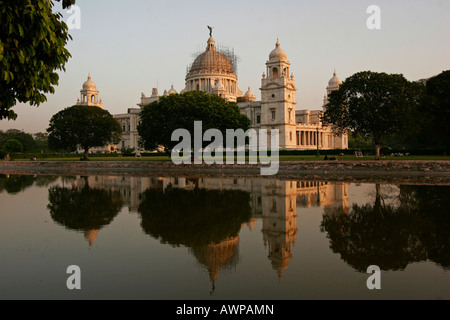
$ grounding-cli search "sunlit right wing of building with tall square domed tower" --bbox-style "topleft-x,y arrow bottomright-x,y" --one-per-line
238,41 -> 348,150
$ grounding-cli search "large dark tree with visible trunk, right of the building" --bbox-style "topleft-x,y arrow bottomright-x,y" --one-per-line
323,71 -> 423,159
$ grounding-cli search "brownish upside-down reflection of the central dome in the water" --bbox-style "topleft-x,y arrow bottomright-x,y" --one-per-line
190,237 -> 239,291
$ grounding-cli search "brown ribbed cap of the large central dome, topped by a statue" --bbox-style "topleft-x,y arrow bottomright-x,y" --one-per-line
189,37 -> 234,74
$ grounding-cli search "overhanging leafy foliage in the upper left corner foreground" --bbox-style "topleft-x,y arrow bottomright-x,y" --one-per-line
0,0 -> 75,120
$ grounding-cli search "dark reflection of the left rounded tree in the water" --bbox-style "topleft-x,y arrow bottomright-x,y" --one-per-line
47,180 -> 123,245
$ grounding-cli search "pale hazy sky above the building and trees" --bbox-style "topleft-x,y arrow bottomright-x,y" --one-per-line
0,0 -> 450,133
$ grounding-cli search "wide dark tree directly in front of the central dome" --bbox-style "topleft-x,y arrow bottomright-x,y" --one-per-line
138,91 -> 250,150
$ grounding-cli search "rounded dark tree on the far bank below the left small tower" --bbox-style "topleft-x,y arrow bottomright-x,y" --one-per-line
47,105 -> 122,157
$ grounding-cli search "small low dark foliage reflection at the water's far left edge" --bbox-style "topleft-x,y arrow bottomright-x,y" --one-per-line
0,174 -> 58,194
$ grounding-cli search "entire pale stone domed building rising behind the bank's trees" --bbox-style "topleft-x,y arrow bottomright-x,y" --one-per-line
78,33 -> 348,150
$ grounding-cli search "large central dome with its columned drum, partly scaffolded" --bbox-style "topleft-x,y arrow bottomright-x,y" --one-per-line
182,28 -> 242,102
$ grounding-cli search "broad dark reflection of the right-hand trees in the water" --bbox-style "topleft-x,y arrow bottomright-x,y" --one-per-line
321,186 -> 450,272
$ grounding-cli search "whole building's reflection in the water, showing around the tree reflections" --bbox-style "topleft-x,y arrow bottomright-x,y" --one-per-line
73,176 -> 348,276
